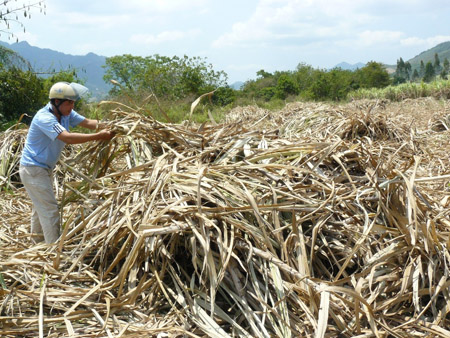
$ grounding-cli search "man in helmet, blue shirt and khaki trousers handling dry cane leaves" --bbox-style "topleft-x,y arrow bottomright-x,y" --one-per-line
19,82 -> 114,243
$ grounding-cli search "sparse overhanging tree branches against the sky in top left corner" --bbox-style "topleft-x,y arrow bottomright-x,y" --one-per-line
0,0 -> 46,41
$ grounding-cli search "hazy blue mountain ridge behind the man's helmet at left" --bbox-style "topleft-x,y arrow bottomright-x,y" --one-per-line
0,41 -> 111,99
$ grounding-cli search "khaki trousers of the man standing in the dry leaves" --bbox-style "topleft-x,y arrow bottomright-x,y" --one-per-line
19,166 -> 61,243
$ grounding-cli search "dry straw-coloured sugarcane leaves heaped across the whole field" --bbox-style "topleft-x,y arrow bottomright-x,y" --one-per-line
0,99 -> 450,337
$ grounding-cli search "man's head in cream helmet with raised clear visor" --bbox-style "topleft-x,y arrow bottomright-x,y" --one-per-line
48,82 -> 88,115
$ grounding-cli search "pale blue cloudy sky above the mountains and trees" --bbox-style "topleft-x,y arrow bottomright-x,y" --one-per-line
0,0 -> 450,84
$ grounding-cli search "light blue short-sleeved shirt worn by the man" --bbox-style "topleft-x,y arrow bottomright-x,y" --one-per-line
20,103 -> 85,169
